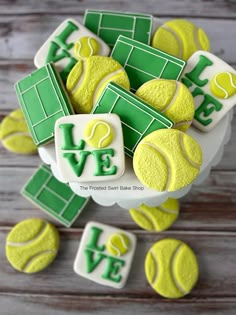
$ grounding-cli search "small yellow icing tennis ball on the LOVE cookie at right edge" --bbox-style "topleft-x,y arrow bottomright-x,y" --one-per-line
210,72 -> 236,99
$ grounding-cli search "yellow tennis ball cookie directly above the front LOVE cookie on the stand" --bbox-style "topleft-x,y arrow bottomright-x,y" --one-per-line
66,56 -> 130,114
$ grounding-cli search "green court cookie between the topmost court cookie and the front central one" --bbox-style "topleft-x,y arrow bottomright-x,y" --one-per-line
111,35 -> 185,91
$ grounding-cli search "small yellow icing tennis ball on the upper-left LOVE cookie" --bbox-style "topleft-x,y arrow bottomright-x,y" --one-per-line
74,36 -> 100,59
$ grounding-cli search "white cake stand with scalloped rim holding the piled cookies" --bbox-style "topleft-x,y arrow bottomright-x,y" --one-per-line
39,111 -> 233,209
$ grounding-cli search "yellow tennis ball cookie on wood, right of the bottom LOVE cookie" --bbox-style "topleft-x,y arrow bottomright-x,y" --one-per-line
145,238 -> 199,298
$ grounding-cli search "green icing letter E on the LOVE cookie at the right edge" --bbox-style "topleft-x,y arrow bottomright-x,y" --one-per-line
194,94 -> 222,126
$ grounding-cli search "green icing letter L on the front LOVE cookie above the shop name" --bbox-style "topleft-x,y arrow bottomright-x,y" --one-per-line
59,124 -> 85,150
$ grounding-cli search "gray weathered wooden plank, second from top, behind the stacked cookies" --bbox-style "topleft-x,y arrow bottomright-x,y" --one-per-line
0,14 -> 236,64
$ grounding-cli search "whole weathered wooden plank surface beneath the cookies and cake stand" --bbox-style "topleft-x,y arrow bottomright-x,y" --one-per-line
0,0 -> 236,315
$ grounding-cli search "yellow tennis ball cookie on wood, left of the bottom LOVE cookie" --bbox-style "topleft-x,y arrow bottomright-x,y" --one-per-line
6,218 -> 59,273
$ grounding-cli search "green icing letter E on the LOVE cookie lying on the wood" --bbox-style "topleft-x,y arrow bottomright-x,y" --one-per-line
102,256 -> 125,283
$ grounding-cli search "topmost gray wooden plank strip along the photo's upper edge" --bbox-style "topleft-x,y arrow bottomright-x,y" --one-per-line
0,0 -> 236,18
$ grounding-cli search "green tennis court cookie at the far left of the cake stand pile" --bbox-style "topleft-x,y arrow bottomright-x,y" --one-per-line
15,63 -> 73,146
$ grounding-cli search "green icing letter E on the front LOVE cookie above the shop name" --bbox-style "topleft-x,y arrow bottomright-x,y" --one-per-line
92,149 -> 117,176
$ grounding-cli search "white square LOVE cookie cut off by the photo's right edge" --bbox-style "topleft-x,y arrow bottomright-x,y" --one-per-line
181,51 -> 236,131
